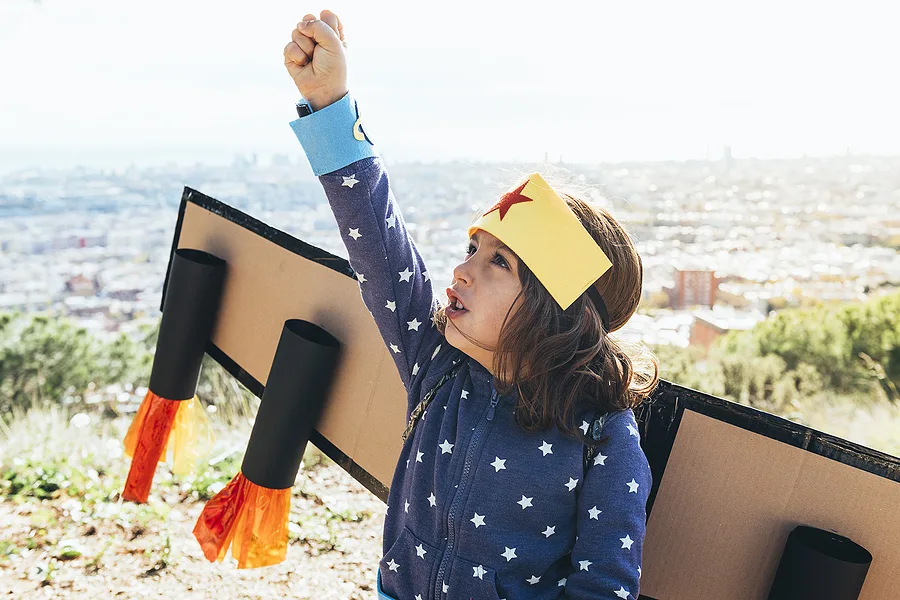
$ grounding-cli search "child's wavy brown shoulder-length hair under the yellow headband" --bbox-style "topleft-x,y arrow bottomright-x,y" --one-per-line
434,173 -> 659,442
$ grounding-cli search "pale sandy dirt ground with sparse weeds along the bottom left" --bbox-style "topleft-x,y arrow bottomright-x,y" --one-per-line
0,463 -> 385,600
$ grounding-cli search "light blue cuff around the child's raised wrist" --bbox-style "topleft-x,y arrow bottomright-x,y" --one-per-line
291,92 -> 378,177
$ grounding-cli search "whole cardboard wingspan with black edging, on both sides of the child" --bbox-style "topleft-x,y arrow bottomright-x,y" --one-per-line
163,188 -> 900,600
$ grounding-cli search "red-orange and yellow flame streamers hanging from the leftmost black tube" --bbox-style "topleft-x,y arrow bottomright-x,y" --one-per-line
122,391 -> 213,503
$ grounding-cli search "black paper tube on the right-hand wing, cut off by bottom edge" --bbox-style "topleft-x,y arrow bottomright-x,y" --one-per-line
769,525 -> 872,600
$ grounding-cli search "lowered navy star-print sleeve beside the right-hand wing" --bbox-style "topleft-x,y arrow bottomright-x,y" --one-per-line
565,410 -> 652,600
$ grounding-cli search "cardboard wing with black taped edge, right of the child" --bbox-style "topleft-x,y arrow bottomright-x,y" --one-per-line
639,382 -> 900,600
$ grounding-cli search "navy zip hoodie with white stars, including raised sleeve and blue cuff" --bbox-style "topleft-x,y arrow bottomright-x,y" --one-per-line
290,94 -> 651,600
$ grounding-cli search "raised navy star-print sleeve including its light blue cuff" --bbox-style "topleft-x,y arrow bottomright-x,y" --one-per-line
291,93 -> 442,391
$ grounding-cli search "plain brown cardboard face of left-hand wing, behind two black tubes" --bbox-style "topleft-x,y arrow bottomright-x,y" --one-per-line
176,191 -> 406,499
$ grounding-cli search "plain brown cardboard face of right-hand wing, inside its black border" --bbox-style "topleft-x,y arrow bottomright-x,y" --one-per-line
641,410 -> 900,600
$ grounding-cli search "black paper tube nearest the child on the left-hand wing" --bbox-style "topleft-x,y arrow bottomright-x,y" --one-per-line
241,319 -> 340,489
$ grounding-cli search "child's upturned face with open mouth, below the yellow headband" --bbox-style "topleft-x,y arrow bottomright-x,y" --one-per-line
444,229 -> 522,375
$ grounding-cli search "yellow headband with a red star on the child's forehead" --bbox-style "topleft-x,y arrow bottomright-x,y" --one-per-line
469,173 -> 612,310
